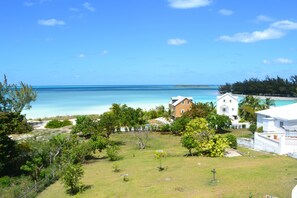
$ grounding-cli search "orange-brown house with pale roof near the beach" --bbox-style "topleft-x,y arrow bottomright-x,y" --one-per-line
169,96 -> 193,118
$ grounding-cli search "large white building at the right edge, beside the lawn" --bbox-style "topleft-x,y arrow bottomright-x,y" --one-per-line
254,103 -> 297,155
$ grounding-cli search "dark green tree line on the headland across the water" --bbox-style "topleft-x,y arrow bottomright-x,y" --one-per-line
219,75 -> 297,97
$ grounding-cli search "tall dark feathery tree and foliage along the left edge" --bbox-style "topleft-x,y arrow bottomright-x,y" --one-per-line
0,76 -> 36,177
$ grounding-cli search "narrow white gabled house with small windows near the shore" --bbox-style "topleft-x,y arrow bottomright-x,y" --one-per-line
217,93 -> 238,118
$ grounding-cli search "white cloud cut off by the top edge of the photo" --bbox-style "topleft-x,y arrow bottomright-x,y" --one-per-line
168,0 -> 212,9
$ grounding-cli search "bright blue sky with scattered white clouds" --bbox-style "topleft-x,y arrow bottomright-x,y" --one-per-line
0,0 -> 297,85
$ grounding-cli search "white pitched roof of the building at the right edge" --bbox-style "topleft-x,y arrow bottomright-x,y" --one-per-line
256,103 -> 297,120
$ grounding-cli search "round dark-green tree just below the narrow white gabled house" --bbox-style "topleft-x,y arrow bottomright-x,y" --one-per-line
206,113 -> 232,132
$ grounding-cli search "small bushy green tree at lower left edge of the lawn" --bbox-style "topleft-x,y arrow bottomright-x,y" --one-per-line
61,163 -> 84,194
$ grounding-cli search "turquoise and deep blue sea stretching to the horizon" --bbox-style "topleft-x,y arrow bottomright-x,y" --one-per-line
23,85 -> 297,119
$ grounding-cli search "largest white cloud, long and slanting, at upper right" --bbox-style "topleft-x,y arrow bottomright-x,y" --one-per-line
219,20 -> 297,43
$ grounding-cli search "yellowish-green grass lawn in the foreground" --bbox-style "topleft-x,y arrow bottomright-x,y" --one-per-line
39,133 -> 297,198
